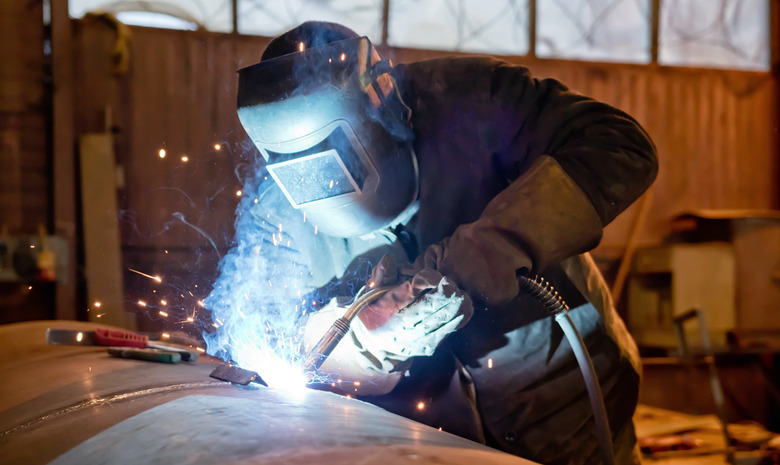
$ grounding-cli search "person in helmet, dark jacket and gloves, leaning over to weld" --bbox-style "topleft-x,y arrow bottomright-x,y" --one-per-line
238,22 -> 657,464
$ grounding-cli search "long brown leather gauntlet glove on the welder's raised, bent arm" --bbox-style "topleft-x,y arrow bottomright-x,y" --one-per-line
418,155 -> 601,306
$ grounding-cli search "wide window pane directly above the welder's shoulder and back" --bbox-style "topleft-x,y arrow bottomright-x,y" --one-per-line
388,0 -> 528,55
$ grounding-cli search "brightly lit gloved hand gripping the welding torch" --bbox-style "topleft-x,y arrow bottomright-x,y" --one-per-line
353,255 -> 473,361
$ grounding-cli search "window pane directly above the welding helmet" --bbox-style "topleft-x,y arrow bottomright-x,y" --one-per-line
238,0 -> 383,43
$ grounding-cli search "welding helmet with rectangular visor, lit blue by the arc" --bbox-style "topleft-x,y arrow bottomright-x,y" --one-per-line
238,23 -> 418,237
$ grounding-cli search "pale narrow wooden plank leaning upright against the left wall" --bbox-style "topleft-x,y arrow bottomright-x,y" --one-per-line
79,133 -> 135,329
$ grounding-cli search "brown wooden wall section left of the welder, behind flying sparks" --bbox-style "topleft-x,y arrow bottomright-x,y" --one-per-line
73,19 -> 274,329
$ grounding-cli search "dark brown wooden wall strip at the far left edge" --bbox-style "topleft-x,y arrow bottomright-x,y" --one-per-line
0,1 -> 55,324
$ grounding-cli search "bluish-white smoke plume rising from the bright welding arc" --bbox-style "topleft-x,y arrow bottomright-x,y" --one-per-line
204,175 -> 320,385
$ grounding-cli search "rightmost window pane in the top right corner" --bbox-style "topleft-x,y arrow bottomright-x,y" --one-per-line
658,0 -> 769,71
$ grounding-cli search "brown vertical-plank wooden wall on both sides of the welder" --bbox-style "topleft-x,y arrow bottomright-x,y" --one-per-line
74,21 -> 780,326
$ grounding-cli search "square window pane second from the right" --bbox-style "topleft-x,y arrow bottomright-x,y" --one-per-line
536,0 -> 651,63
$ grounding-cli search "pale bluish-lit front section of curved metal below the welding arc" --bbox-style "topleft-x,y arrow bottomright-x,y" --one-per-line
52,387 -> 532,465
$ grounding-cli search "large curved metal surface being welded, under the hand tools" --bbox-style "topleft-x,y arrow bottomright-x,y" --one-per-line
0,321 -> 531,465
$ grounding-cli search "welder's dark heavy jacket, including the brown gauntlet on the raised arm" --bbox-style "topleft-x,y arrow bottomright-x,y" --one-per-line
304,58 -> 657,464
